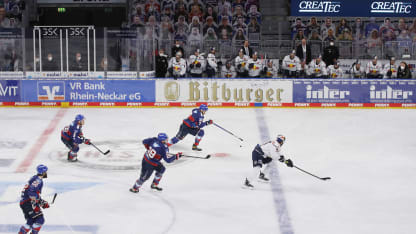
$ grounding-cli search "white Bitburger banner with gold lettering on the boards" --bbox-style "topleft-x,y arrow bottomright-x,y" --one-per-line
156,79 -> 293,103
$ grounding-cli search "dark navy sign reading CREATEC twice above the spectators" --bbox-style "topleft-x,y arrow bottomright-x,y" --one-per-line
291,0 -> 416,17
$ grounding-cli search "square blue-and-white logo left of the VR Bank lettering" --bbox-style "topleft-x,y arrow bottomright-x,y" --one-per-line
38,81 -> 65,101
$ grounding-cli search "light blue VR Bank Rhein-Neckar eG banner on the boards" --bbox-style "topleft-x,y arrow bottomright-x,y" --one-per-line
22,80 -> 155,102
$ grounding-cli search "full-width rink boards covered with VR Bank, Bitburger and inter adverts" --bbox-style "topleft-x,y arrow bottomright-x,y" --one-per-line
0,79 -> 416,108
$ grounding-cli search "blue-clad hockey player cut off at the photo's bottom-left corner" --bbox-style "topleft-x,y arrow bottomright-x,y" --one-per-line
19,164 -> 49,234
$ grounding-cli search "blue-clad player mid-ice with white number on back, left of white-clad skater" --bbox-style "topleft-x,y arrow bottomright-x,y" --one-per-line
130,133 -> 182,193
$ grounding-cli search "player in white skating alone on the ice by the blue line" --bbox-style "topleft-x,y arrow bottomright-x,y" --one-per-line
243,135 -> 293,188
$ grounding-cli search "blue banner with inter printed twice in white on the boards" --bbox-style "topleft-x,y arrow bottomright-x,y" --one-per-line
293,80 -> 416,103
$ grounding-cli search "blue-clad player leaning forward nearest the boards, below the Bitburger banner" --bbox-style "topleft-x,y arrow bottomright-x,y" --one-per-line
169,104 -> 214,151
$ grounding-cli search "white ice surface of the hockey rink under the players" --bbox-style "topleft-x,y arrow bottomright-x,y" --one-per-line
0,108 -> 416,234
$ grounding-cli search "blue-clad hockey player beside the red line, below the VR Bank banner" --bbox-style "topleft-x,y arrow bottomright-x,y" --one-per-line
61,114 -> 91,162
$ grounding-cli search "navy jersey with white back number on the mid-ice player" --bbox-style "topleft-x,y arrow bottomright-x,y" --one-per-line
143,137 -> 176,166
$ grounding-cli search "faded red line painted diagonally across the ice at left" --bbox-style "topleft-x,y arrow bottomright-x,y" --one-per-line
16,108 -> 68,172
